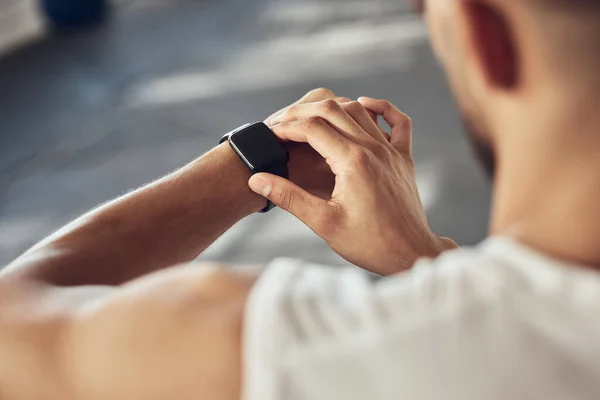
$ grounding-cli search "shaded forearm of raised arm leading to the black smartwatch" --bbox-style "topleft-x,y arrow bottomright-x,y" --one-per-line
4,144 -> 265,286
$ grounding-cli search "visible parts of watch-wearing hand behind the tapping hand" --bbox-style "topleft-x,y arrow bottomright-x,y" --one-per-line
264,88 -> 350,200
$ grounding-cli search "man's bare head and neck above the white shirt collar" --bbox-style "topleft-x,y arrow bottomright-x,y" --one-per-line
426,0 -> 600,268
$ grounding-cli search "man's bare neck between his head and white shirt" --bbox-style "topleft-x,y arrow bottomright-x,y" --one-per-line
491,93 -> 600,269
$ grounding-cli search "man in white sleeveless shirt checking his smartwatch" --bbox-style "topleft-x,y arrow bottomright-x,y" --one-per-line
0,0 -> 600,400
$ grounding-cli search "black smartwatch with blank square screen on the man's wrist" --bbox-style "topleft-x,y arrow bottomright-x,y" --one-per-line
219,122 -> 290,213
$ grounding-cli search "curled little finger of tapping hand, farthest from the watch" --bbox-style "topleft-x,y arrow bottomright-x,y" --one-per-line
358,97 -> 412,155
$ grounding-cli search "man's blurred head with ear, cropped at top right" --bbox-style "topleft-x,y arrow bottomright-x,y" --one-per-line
411,0 -> 600,175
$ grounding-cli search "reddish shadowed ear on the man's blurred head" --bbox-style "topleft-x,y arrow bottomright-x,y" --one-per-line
461,0 -> 519,90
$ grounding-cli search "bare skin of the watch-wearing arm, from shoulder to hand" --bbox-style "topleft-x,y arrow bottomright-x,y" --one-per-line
0,89 -> 450,400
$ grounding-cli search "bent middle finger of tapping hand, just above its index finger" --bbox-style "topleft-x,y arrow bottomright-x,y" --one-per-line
272,99 -> 374,146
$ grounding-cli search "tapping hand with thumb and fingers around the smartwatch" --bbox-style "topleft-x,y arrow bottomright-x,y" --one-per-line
249,98 -> 455,274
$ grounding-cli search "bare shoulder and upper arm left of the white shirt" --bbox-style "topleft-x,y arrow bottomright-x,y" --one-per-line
0,266 -> 254,400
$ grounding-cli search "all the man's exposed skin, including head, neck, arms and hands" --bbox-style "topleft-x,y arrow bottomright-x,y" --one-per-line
0,0 -> 600,400
